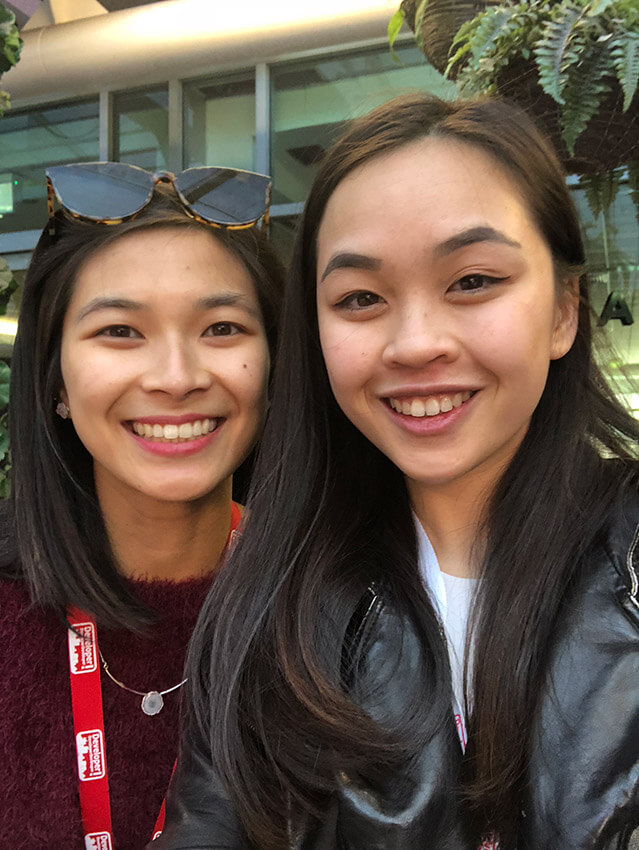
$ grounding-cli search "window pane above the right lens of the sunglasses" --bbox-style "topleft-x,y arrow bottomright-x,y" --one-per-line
184,71 -> 255,171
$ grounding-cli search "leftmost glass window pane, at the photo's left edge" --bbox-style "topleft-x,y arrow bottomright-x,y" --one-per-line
0,98 -> 99,233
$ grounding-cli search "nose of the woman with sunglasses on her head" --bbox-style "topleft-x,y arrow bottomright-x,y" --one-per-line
141,338 -> 213,399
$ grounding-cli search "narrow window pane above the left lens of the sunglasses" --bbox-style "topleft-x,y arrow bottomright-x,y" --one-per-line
113,86 -> 169,171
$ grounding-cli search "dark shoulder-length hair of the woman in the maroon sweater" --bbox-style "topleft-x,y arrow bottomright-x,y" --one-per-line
0,186 -> 283,629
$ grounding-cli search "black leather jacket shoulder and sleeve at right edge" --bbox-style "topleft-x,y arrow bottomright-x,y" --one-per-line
524,480 -> 639,850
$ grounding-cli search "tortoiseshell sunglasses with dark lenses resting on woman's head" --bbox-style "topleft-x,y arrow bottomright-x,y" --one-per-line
45,162 -> 273,235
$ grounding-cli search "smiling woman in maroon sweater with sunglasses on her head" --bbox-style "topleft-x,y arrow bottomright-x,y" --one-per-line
0,163 -> 281,850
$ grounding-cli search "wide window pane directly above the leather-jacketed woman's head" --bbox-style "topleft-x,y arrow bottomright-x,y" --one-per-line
271,44 -> 455,204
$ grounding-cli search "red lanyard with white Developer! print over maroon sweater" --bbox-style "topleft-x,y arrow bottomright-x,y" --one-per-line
67,502 -> 241,850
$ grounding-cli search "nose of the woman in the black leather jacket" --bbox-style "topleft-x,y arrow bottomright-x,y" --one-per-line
382,304 -> 460,369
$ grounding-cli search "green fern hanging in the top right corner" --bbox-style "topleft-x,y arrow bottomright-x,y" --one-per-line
446,0 -> 639,156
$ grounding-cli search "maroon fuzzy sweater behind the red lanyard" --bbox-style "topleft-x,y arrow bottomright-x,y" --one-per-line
0,577 -> 211,850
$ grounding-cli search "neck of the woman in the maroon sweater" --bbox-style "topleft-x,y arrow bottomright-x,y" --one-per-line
96,478 -> 232,581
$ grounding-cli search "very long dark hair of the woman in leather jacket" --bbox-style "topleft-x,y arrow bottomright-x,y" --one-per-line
189,96 -> 639,848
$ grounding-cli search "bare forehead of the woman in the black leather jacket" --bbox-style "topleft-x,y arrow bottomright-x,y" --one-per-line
317,138 -> 539,263
